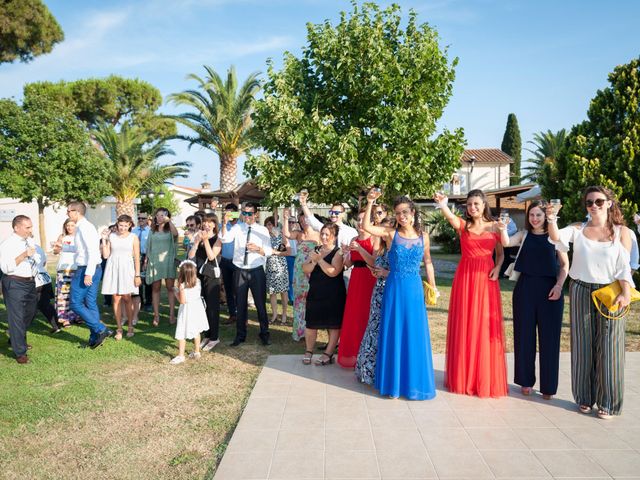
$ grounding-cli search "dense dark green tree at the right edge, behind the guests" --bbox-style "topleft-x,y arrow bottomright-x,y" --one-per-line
540,58 -> 640,221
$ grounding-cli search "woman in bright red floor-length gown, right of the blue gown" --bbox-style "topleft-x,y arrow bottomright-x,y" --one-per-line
435,190 -> 508,397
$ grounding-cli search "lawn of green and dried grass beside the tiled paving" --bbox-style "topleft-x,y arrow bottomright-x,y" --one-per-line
0,255 -> 640,479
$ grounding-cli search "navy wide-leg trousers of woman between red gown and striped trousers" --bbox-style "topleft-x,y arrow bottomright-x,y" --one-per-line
513,274 -> 564,395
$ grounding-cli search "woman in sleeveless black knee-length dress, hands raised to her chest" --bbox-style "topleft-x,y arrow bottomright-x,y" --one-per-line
302,223 -> 347,365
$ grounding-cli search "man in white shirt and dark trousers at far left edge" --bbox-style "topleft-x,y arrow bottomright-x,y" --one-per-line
0,215 -> 38,364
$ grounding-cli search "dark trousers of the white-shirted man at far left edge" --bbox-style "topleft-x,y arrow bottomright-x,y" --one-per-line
2,275 -> 37,357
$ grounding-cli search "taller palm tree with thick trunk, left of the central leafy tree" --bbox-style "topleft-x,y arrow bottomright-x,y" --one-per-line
168,65 -> 260,191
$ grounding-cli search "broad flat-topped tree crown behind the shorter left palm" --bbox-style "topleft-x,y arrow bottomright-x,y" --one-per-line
24,75 -> 176,140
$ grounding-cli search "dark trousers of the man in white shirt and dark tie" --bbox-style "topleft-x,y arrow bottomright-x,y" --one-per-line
233,267 -> 269,342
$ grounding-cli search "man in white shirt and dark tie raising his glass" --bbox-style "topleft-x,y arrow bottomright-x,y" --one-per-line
220,203 -> 271,347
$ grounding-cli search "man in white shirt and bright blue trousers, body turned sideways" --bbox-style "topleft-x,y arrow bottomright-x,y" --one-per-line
67,202 -> 113,348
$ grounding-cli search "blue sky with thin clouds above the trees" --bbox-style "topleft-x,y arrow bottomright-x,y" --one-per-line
0,0 -> 640,187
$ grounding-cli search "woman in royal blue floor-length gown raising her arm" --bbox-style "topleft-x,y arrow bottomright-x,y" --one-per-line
363,189 -> 436,400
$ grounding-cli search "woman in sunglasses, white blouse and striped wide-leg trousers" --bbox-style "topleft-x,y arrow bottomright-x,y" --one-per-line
547,186 -> 633,419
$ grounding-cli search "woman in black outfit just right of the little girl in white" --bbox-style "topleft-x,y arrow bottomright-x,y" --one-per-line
188,213 -> 222,352
